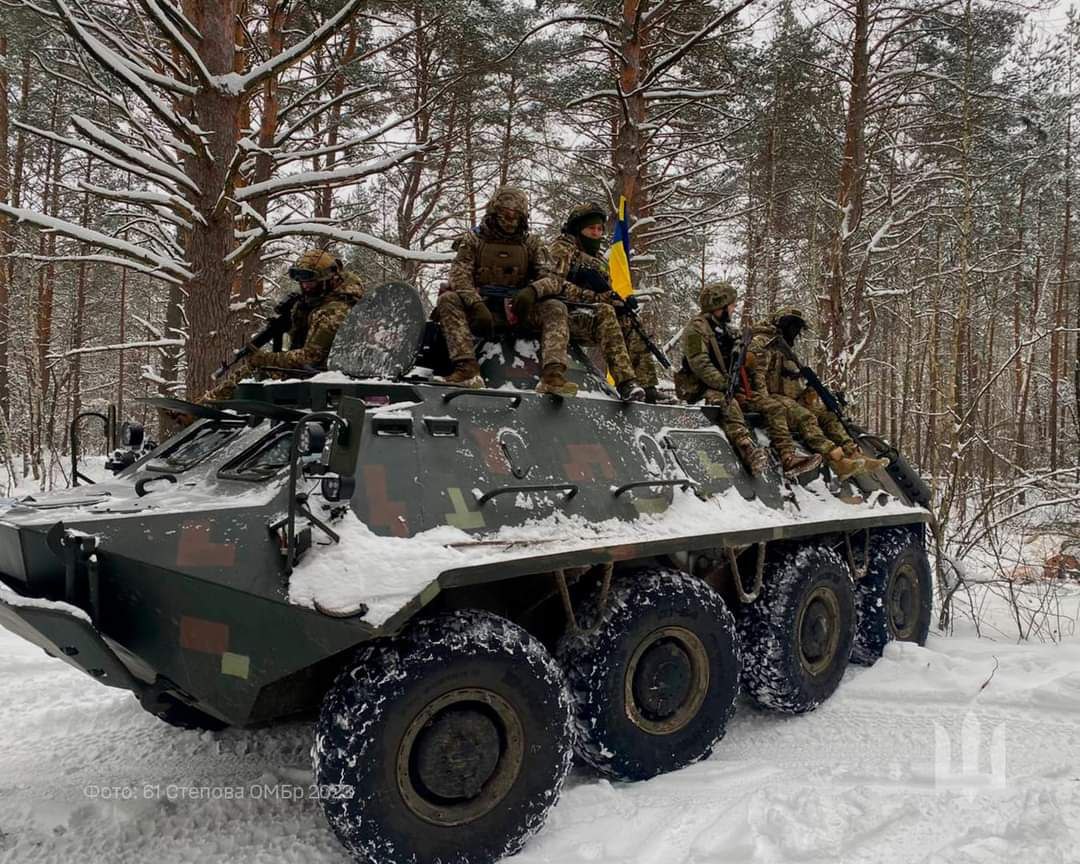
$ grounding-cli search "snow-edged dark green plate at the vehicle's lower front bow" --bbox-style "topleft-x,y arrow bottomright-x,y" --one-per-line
0,585 -> 143,691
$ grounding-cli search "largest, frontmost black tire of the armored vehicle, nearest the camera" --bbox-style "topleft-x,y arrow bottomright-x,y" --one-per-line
312,610 -> 573,864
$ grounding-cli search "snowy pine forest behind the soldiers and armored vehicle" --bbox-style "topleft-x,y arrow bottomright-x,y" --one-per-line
0,0 -> 1080,609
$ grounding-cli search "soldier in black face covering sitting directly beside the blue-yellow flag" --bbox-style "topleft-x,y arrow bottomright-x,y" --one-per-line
514,204 -> 643,402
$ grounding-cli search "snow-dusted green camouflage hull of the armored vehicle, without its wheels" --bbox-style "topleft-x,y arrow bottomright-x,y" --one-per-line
0,375 -> 928,725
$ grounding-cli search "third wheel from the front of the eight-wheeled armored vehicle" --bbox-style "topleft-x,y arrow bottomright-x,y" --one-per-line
739,544 -> 855,714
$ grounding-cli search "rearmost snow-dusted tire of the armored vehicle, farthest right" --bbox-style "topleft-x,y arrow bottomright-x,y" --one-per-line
851,528 -> 933,666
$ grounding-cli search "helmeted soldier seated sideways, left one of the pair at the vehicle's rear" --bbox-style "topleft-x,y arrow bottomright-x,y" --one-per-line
675,282 -> 821,475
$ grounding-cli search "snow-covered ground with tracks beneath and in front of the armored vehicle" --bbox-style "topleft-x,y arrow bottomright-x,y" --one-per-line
0,589 -> 1080,864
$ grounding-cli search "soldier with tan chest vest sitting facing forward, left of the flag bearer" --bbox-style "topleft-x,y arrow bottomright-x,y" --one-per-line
435,186 -> 548,388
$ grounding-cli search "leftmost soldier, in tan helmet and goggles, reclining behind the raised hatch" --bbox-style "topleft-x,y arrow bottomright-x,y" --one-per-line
200,249 -> 364,402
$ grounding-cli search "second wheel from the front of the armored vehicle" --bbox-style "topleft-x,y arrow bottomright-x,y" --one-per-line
556,568 -> 739,780
